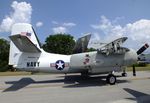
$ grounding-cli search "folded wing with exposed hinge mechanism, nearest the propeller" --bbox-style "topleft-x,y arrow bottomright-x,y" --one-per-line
100,37 -> 128,54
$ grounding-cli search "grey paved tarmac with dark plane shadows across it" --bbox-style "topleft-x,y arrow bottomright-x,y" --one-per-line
0,71 -> 150,103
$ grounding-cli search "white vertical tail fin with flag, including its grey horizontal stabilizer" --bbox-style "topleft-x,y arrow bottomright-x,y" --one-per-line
9,23 -> 41,65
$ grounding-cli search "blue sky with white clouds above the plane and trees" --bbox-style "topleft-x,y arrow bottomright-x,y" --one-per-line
0,0 -> 150,51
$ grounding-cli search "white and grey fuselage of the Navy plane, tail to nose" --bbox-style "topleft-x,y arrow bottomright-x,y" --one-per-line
16,50 -> 137,74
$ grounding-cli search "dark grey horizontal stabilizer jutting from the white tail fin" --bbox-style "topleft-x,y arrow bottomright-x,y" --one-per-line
9,34 -> 41,53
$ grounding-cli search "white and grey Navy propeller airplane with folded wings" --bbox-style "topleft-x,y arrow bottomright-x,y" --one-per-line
9,23 -> 149,85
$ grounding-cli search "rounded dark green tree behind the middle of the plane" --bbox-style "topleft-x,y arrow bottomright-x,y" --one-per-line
43,34 -> 75,55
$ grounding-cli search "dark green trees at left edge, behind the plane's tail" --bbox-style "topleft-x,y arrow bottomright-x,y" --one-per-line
0,39 -> 9,71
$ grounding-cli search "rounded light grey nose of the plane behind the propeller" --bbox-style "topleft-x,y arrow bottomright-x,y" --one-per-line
124,49 -> 138,66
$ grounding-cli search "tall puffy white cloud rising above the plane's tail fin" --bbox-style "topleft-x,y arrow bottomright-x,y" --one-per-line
0,1 -> 32,32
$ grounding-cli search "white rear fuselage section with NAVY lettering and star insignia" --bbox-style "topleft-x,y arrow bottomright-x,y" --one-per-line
19,50 -> 71,72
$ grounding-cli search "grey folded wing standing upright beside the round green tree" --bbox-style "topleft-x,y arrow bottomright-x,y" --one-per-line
73,34 -> 91,53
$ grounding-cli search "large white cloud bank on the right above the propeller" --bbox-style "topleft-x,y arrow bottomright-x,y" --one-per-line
91,16 -> 150,49
